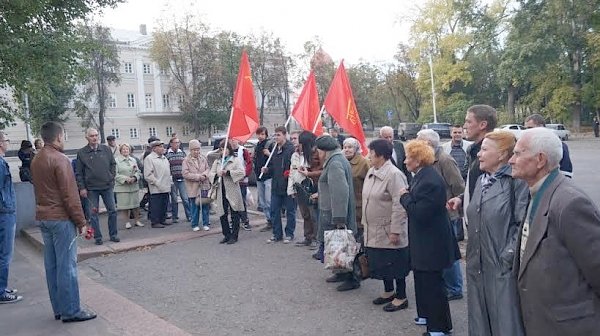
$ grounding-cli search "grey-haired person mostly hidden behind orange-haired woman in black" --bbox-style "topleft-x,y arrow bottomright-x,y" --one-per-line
417,129 -> 465,301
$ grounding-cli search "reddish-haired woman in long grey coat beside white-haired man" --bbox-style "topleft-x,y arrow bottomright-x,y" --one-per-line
467,131 -> 529,336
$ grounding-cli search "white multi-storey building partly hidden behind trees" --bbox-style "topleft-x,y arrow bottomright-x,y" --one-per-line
4,25 -> 285,149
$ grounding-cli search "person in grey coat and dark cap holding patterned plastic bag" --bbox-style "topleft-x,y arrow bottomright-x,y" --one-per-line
316,135 -> 360,292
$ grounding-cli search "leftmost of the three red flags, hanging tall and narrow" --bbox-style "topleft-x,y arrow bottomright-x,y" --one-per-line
227,50 -> 258,142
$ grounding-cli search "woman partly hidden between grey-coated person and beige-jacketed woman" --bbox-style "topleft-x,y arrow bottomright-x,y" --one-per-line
343,138 -> 369,239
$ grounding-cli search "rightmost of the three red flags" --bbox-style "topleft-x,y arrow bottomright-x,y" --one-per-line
325,61 -> 369,155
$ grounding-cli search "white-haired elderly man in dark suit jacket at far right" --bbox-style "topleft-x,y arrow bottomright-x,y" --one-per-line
509,128 -> 600,336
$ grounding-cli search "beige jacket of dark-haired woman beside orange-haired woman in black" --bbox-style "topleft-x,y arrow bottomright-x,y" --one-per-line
362,160 -> 408,249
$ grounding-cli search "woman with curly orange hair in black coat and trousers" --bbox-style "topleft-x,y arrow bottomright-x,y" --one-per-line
400,140 -> 460,336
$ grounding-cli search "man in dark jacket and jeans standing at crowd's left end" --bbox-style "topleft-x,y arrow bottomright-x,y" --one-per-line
75,128 -> 121,245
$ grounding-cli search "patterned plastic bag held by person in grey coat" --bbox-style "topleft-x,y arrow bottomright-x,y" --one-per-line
324,229 -> 360,271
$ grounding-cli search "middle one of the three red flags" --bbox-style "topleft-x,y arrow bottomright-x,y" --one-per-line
292,71 -> 323,136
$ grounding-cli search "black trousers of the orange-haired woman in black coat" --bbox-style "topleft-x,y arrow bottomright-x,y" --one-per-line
413,270 -> 452,333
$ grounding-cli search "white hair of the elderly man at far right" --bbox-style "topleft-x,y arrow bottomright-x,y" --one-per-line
521,127 -> 563,170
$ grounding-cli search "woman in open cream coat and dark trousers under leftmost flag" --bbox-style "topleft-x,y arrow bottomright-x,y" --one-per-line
208,141 -> 246,244
